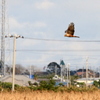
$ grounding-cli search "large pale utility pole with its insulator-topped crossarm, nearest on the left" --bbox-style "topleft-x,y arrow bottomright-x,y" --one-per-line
5,34 -> 24,91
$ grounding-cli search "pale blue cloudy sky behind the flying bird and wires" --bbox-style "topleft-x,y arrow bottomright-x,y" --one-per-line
1,0 -> 100,69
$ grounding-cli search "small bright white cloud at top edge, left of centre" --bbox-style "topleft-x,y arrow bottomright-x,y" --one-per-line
35,0 -> 55,9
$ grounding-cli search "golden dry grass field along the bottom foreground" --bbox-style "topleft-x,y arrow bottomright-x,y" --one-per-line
0,91 -> 100,100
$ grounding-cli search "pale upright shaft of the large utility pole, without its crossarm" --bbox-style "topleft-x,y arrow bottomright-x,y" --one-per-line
12,36 -> 16,91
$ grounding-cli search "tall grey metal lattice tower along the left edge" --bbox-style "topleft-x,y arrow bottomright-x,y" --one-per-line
0,0 -> 5,75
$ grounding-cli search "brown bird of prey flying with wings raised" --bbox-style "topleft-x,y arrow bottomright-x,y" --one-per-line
64,23 -> 79,38
